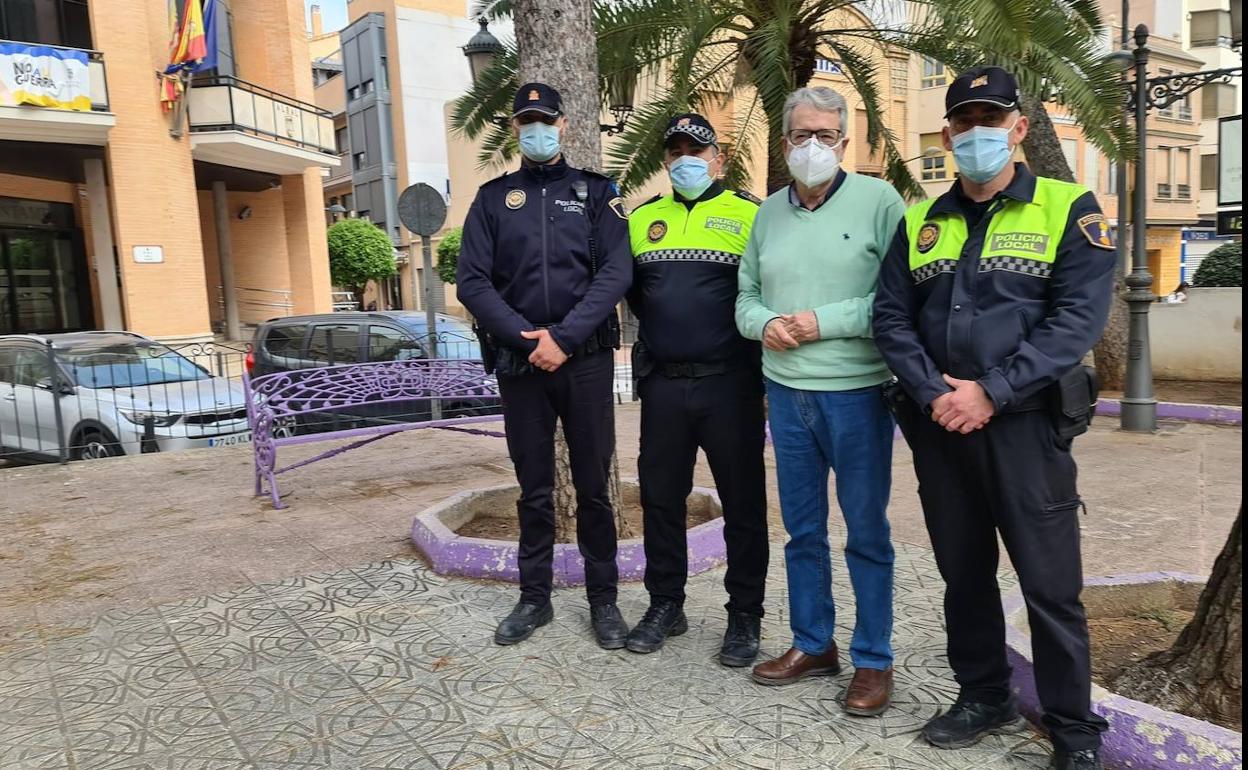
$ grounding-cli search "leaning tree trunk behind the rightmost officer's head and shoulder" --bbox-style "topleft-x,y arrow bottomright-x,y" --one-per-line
1022,96 -> 1131,391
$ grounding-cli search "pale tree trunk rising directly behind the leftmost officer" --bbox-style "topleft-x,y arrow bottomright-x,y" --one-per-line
512,0 -> 631,543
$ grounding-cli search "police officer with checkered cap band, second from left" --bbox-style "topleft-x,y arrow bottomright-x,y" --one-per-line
628,114 -> 768,666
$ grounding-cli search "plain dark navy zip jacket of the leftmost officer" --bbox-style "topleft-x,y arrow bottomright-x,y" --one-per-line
456,158 -> 633,354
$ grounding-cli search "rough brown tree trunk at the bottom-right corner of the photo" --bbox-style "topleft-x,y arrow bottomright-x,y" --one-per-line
1113,507 -> 1244,731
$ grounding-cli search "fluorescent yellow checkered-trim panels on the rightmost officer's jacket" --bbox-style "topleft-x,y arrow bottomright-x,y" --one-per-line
906,177 -> 1087,283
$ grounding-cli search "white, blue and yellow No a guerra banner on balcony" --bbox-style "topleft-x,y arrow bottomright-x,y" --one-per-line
0,42 -> 91,112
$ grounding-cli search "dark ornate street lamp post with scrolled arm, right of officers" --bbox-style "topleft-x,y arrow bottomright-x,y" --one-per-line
1119,24 -> 1243,432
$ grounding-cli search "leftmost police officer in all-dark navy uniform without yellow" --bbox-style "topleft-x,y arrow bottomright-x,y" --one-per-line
457,82 -> 631,649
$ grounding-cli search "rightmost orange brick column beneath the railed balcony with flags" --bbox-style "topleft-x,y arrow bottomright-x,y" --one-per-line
282,167 -> 333,316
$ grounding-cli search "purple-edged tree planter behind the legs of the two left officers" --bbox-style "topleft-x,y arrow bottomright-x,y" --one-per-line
412,482 -> 728,587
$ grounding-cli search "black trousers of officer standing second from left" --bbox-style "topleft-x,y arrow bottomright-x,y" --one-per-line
638,367 -> 768,616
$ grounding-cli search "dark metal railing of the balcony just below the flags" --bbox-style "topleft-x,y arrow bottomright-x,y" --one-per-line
188,76 -> 338,157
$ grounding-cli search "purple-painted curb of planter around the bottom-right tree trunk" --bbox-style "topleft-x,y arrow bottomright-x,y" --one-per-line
1002,573 -> 1243,770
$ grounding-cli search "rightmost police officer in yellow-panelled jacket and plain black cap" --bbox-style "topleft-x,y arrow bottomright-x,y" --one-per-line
874,67 -> 1114,770
